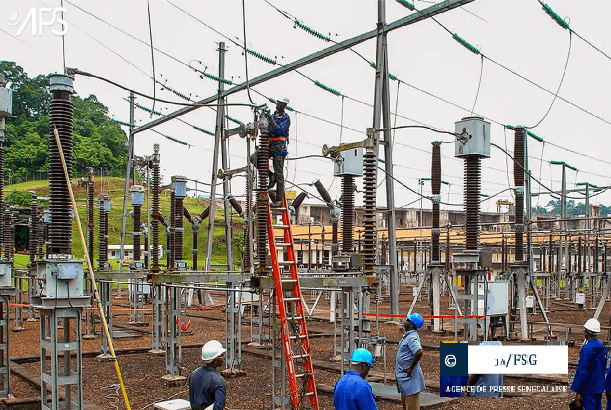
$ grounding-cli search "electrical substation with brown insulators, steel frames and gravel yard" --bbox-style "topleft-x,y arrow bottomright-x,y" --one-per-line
0,0 -> 611,410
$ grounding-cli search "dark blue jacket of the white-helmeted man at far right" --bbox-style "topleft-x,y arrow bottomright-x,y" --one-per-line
571,339 -> 607,395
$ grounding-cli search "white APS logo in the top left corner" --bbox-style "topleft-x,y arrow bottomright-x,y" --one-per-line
6,7 -> 68,36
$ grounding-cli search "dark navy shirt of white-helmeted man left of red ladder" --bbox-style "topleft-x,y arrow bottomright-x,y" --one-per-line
189,365 -> 227,410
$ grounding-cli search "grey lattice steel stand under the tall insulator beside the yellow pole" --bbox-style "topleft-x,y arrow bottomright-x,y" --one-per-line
40,307 -> 83,410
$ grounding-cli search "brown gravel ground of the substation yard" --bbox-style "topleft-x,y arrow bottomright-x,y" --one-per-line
3,286 -> 611,410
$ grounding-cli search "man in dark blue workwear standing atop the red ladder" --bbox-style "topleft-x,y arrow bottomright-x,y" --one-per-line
267,98 -> 291,208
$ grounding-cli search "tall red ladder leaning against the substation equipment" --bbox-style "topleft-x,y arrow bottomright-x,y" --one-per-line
267,195 -> 319,410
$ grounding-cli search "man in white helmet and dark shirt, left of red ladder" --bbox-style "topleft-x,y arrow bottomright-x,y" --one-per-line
189,340 -> 227,410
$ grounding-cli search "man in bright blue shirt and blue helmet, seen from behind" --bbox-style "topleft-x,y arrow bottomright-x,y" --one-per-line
333,347 -> 377,410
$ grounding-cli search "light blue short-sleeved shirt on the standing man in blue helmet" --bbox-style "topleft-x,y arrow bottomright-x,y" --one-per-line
395,330 -> 426,396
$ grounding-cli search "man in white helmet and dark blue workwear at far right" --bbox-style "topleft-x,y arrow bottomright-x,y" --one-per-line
571,318 -> 607,410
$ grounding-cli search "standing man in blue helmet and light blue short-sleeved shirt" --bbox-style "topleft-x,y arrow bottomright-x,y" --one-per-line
395,313 -> 426,410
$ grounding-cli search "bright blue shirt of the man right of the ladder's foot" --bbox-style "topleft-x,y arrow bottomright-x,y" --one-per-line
333,370 -> 378,410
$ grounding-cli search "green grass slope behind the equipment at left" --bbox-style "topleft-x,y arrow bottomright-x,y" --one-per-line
6,177 -> 243,270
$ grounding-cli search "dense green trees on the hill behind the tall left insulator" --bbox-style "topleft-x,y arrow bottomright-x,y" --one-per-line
0,61 -> 127,181
